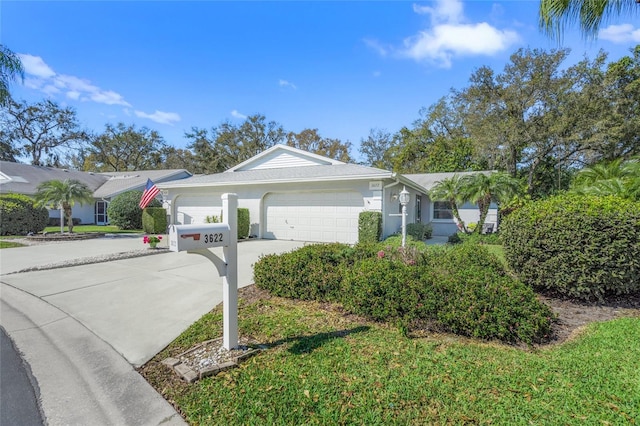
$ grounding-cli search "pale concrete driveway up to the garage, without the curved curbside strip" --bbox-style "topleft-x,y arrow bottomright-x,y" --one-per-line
0,237 -> 304,366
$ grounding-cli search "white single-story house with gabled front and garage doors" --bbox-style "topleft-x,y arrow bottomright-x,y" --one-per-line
158,145 -> 497,243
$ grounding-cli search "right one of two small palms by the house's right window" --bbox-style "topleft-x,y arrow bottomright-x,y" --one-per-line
461,172 -> 520,234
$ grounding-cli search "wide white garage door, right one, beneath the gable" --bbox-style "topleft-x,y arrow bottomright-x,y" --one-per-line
263,192 -> 364,243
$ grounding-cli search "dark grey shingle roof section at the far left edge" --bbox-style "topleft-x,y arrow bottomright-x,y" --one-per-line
0,161 -> 108,195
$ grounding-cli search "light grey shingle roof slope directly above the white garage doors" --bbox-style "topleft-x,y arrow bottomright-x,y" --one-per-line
158,164 -> 393,188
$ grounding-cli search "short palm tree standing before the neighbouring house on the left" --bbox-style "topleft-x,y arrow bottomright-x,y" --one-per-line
35,179 -> 93,233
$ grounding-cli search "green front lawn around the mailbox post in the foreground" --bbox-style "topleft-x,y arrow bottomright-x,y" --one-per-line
143,292 -> 640,425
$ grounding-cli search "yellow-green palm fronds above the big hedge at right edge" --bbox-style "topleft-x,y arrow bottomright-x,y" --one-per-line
572,157 -> 640,201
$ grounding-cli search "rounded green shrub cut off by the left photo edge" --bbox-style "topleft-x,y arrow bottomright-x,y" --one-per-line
0,194 -> 49,235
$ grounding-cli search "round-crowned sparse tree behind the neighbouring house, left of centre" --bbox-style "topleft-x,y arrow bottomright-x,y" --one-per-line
83,123 -> 169,172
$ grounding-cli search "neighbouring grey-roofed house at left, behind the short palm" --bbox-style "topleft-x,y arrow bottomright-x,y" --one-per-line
0,161 -> 191,225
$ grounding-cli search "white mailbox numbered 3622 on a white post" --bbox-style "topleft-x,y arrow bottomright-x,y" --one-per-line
169,223 -> 231,251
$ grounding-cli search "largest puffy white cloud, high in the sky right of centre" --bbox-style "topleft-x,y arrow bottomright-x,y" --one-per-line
384,0 -> 520,68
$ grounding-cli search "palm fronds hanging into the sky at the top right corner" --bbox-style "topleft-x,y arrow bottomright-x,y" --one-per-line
539,0 -> 640,38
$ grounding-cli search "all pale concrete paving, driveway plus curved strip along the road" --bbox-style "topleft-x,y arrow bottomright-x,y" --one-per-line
0,237 -> 303,425
